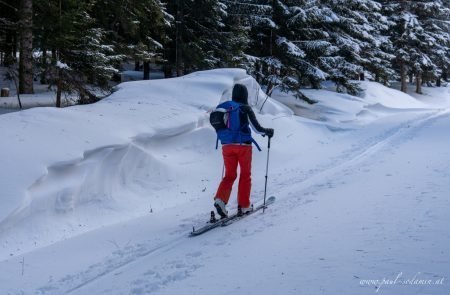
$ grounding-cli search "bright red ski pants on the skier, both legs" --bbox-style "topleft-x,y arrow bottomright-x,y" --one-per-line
216,144 -> 252,208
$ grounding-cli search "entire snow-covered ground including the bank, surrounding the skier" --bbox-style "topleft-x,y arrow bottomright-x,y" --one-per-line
0,69 -> 450,294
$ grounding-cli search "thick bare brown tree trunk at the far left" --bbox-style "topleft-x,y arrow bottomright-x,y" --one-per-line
19,0 -> 33,94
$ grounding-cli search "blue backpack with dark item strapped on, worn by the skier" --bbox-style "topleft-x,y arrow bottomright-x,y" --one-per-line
209,101 -> 261,151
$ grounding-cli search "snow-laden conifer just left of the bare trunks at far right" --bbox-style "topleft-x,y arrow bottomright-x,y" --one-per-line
313,0 -> 393,93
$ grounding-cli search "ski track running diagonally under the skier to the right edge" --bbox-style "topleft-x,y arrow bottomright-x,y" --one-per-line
29,110 -> 449,294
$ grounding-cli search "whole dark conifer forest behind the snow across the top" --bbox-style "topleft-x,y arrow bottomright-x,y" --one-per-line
0,0 -> 450,106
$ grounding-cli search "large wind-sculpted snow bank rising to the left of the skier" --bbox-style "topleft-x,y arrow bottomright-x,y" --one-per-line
0,69 -> 291,257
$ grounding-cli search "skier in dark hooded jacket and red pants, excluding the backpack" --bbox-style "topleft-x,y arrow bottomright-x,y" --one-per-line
214,84 -> 274,218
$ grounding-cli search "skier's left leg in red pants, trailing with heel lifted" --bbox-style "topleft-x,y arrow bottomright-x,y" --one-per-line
216,145 -> 239,204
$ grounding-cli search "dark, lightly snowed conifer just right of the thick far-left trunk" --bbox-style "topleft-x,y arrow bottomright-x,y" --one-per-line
35,0 -> 119,107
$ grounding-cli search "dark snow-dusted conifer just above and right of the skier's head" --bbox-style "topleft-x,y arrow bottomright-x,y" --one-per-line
225,0 -> 324,102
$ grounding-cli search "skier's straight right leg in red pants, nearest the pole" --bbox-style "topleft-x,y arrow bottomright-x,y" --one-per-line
238,146 -> 252,208
